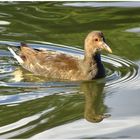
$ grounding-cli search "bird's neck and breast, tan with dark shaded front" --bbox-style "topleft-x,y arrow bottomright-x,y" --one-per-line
84,53 -> 105,79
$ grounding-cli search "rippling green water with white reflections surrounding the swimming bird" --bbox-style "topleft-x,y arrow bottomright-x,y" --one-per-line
0,2 -> 140,139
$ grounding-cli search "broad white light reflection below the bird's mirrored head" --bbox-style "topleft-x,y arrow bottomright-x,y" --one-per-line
32,117 -> 140,139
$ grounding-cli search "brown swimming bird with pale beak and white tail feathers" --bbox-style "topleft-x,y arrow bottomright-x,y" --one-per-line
8,31 -> 112,81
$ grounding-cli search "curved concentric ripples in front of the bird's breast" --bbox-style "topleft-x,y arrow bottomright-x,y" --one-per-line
104,55 -> 138,86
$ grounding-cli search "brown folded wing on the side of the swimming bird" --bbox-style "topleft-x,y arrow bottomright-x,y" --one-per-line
16,47 -> 78,74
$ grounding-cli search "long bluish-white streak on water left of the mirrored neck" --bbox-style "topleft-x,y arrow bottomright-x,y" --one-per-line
0,87 -> 77,105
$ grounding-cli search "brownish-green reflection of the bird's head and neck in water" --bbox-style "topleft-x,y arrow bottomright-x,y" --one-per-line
81,79 -> 110,123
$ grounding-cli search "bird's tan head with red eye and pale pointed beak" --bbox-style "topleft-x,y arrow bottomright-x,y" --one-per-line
85,31 -> 112,54
